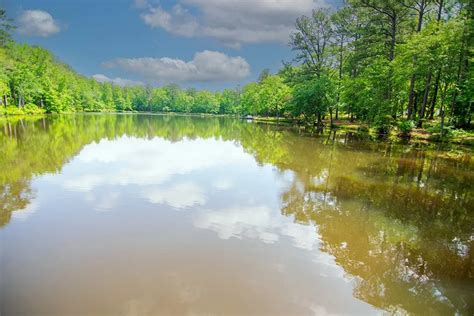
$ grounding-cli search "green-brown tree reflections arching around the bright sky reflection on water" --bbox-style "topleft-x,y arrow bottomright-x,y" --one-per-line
0,115 -> 474,314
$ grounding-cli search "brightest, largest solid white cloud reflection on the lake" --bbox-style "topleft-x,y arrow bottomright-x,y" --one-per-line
59,137 -> 251,192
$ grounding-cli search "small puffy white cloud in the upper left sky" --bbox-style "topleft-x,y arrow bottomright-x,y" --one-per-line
18,10 -> 61,37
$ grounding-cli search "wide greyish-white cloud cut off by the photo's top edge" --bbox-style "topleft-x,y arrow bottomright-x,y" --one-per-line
140,0 -> 329,47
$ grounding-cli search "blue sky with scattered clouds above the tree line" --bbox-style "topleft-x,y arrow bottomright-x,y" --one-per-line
0,0 -> 338,90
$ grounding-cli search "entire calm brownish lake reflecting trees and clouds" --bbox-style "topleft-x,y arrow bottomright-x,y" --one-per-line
0,114 -> 474,315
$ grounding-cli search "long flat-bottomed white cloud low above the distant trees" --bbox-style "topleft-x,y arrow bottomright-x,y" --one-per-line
104,50 -> 250,83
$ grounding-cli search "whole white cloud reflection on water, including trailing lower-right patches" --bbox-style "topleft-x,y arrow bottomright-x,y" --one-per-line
38,137 -> 318,250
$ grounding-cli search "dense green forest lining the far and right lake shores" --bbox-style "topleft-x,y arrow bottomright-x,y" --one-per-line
0,0 -> 474,133
